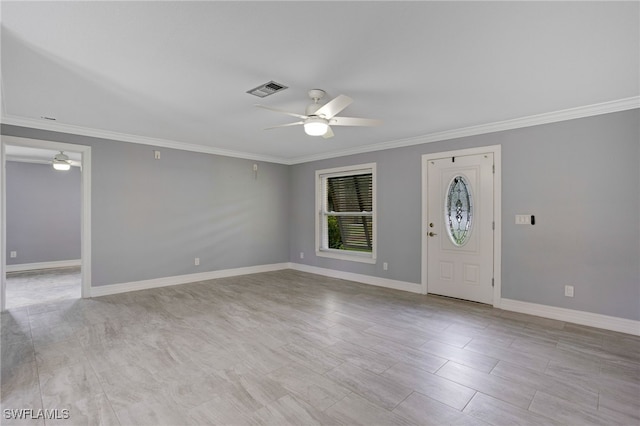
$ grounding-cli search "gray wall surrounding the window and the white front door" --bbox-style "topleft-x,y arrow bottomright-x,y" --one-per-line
289,110 -> 640,320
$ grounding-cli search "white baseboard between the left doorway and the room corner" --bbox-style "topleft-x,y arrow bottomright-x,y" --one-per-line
91,263 -> 289,297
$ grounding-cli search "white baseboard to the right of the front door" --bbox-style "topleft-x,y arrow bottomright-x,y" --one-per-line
500,299 -> 640,336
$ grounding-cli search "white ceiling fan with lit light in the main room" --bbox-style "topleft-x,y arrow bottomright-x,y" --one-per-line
256,89 -> 382,139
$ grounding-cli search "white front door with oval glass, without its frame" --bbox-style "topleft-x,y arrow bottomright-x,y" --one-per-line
426,152 -> 495,304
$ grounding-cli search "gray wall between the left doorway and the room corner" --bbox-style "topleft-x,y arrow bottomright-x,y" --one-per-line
2,125 -> 289,286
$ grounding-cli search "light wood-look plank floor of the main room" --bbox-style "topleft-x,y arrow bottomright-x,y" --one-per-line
0,270 -> 640,426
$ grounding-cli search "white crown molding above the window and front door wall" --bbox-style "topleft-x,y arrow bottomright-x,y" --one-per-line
289,96 -> 640,164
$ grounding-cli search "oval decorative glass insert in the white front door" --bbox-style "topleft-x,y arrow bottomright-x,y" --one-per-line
444,175 -> 473,247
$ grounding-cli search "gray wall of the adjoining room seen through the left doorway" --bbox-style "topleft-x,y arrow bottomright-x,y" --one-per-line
6,161 -> 81,265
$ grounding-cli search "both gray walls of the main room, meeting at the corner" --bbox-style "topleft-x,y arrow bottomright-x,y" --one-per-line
2,110 -> 640,320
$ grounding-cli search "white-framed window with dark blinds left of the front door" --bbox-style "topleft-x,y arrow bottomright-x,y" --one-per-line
316,163 -> 376,263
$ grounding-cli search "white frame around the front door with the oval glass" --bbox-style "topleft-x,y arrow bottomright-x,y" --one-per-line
420,145 -> 502,308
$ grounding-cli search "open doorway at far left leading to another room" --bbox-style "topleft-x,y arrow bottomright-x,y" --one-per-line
0,136 -> 91,311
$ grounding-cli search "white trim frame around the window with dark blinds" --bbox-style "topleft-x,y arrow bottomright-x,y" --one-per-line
315,163 -> 378,264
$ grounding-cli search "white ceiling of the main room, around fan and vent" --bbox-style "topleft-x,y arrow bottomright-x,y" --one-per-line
1,1 -> 640,163
